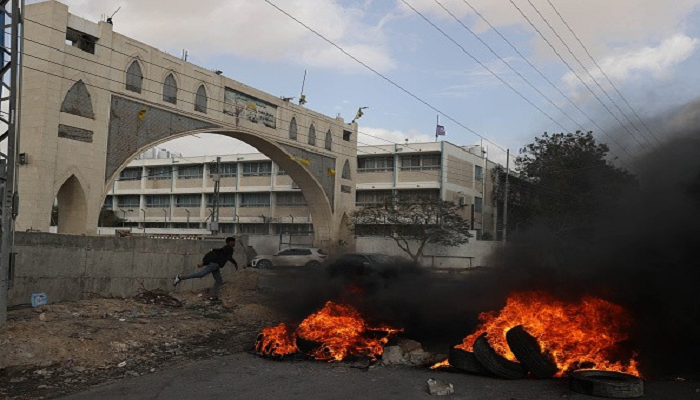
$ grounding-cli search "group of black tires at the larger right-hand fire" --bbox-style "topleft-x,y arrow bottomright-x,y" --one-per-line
448,325 -> 644,399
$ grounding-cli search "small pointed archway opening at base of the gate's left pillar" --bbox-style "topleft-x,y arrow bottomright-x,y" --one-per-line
56,175 -> 87,234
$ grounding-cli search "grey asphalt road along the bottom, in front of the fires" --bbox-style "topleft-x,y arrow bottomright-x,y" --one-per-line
58,353 -> 700,400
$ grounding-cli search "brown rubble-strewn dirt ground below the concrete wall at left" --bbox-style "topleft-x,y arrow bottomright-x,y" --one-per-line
0,269 -> 280,399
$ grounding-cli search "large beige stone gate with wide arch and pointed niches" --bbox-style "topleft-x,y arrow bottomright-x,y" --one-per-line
16,1 -> 357,248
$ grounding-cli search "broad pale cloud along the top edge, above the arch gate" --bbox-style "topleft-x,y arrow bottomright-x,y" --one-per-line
50,0 -> 395,71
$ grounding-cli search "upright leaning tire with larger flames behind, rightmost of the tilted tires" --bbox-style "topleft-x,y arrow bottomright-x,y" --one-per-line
506,325 -> 558,379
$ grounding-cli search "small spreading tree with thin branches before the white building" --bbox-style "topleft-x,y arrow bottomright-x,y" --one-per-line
350,195 -> 471,262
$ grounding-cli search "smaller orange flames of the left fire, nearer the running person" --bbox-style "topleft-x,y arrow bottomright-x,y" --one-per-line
255,301 -> 401,361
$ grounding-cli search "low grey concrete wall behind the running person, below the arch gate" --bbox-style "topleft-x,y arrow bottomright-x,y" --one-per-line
8,232 -> 246,305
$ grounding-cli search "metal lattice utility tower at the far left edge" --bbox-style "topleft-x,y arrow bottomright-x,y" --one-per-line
0,0 -> 24,325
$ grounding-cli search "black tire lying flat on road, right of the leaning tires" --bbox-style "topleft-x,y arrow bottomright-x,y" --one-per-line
569,370 -> 644,399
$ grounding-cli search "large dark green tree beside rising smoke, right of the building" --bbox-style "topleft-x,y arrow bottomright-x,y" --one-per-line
509,131 -> 637,237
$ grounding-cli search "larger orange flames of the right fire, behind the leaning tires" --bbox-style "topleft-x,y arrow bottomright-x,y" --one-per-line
455,292 -> 640,376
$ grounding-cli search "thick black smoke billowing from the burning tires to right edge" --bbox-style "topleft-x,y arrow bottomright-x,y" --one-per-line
266,97 -> 700,378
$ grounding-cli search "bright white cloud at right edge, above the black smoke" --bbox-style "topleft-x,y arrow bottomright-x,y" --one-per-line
563,34 -> 700,88
